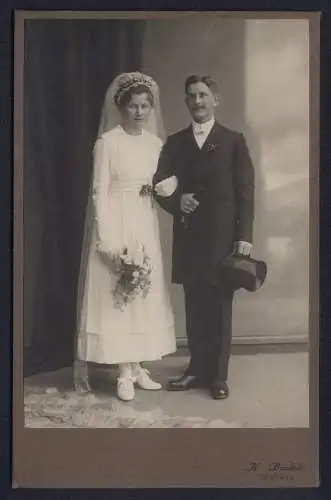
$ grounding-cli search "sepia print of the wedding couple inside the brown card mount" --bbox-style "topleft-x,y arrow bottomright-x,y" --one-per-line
14,12 -> 318,488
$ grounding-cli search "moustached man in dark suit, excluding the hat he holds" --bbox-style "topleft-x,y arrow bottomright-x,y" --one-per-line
153,75 -> 254,399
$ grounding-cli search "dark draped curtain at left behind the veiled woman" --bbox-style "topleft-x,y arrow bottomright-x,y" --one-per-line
24,20 -> 145,375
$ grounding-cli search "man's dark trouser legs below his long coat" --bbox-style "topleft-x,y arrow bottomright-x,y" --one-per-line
184,282 -> 233,384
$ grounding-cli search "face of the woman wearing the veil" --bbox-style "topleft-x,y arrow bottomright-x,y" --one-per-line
121,92 -> 152,131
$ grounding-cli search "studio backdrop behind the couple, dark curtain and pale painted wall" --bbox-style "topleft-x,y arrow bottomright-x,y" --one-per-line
24,17 -> 309,373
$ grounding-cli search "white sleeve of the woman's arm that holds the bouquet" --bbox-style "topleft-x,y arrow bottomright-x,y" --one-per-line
92,137 -> 110,251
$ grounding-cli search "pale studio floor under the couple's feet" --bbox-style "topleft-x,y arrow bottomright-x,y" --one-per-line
25,352 -> 309,428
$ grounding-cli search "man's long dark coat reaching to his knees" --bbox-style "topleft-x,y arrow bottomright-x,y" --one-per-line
153,122 -> 254,284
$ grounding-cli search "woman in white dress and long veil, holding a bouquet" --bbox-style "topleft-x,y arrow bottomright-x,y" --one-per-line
75,72 -> 176,401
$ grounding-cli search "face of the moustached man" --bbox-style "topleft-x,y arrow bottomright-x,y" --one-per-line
185,82 -> 218,123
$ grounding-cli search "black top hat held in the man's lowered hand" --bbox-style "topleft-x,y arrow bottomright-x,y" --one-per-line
219,254 -> 267,292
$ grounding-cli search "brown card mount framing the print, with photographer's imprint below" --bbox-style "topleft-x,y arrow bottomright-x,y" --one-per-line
12,10 -> 320,488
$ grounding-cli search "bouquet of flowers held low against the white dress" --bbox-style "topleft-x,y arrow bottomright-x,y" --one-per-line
111,247 -> 152,310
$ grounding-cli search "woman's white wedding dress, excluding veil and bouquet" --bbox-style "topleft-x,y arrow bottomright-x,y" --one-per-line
78,126 -> 176,364
